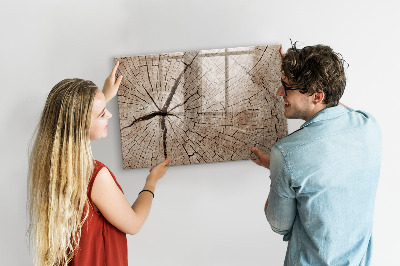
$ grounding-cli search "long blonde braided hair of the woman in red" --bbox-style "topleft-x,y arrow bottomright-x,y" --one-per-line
28,79 -> 97,265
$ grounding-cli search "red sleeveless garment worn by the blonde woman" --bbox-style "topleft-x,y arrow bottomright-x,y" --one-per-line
68,160 -> 128,266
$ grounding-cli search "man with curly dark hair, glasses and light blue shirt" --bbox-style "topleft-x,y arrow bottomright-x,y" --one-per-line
252,44 -> 381,266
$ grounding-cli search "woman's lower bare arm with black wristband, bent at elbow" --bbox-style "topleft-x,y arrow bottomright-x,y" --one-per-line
91,158 -> 171,235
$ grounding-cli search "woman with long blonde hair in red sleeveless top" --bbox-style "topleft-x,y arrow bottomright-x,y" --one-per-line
28,62 -> 170,266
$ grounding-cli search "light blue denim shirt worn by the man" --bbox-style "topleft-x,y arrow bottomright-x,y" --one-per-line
266,105 -> 381,266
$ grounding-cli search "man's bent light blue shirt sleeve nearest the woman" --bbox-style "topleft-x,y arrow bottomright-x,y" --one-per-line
266,146 -> 297,241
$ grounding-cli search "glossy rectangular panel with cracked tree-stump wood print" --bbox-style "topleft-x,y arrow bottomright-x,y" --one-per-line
115,45 -> 287,168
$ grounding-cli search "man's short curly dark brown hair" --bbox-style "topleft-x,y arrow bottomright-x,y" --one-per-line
282,42 -> 348,107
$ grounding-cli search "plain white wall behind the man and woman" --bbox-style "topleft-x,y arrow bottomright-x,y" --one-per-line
0,0 -> 400,266
